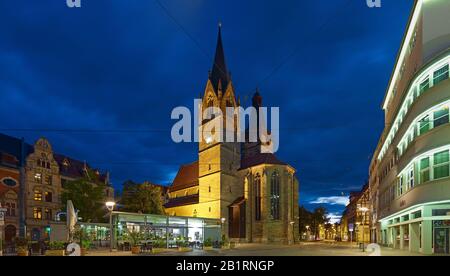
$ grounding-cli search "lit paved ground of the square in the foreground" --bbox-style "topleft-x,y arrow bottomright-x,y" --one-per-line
90,242 -> 421,256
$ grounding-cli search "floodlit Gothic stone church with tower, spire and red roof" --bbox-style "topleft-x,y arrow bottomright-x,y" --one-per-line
165,27 -> 299,244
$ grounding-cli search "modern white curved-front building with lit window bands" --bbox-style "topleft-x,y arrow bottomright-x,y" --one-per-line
370,0 -> 450,254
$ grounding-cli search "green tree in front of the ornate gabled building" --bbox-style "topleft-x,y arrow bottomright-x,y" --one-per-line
61,171 -> 107,222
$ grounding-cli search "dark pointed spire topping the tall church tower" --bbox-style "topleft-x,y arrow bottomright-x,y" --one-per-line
209,23 -> 230,93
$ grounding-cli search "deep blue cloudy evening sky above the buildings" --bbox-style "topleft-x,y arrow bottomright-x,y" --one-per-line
0,0 -> 413,220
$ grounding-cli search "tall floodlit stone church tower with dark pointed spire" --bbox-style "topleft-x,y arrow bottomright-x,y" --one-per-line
198,25 -> 243,234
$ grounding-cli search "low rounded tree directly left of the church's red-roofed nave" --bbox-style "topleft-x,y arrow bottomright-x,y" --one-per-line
121,180 -> 165,215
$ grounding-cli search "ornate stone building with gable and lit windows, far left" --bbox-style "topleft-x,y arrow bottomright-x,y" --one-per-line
0,134 -> 114,242
